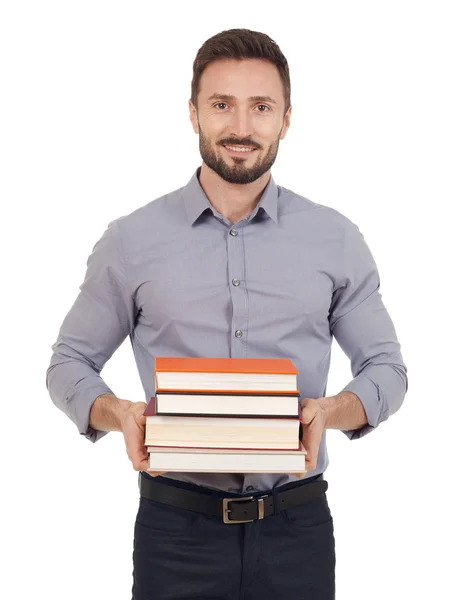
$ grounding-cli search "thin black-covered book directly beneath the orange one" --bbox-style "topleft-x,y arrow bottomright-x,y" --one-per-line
153,392 -> 299,417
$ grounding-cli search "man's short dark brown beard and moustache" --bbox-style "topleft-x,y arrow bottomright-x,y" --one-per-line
199,124 -> 282,184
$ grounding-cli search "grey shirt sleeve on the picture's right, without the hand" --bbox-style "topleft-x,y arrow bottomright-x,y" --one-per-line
329,219 -> 408,439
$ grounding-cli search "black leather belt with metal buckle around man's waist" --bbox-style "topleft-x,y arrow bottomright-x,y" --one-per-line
139,472 -> 328,523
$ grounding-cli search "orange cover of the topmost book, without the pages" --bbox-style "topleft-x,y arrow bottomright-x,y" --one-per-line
155,356 -> 298,375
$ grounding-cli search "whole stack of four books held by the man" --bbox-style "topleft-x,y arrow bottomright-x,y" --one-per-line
144,357 -> 306,477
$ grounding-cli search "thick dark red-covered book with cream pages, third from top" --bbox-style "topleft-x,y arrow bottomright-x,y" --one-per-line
144,398 -> 301,450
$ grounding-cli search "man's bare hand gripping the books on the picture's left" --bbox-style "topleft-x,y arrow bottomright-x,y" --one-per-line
120,402 -> 167,477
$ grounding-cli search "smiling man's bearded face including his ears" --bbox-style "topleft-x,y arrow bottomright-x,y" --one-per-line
189,59 -> 291,184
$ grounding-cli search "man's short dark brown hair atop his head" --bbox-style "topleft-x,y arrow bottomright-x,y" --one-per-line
191,29 -> 290,112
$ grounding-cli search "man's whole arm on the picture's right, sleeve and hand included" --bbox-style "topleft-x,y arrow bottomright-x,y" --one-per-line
301,219 -> 408,470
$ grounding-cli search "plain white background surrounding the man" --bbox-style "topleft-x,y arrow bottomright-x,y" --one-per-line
0,0 -> 454,600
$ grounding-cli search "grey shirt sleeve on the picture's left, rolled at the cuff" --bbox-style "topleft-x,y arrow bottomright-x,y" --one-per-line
46,219 -> 136,442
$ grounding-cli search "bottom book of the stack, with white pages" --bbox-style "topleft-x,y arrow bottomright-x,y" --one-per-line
148,443 -> 307,477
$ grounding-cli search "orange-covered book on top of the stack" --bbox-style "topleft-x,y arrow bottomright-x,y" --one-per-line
155,356 -> 299,394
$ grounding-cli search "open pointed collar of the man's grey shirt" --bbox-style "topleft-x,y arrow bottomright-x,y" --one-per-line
182,167 -> 279,225
